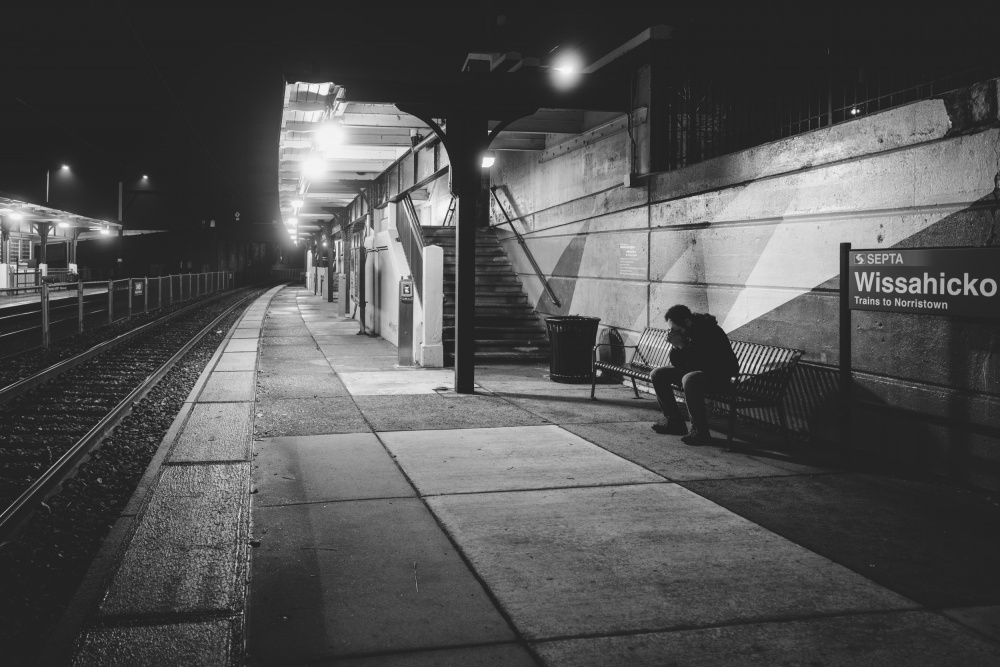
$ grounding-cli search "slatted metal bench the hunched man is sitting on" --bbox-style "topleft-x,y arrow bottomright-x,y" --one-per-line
590,327 -> 802,444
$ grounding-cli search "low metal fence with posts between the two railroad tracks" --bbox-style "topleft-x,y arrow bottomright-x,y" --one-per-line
0,270 -> 292,357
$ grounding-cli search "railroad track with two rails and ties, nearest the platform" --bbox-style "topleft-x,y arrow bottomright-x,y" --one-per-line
0,290 -> 261,540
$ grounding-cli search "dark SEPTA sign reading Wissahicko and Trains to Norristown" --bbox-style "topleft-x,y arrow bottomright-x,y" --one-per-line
848,248 -> 1000,319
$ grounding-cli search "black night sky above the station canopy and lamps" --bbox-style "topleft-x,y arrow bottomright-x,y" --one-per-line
0,0 -> 996,245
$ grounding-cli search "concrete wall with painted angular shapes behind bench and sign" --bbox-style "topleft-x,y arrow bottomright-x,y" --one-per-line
491,81 -> 1000,490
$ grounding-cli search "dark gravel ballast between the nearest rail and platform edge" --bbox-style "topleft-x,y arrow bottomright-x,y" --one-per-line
0,290 -> 264,665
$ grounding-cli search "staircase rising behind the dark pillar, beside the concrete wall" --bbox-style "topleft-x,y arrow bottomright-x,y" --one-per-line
422,227 -> 549,366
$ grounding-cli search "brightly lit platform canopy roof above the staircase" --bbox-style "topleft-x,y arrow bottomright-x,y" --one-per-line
278,37 -> 648,241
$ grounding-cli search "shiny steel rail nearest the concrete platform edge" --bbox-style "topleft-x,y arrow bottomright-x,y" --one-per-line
0,294 -> 255,540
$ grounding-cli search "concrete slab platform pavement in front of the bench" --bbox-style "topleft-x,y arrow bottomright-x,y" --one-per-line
50,288 -> 1000,666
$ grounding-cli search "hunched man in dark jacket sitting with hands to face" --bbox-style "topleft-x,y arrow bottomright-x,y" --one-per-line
650,304 -> 740,445
